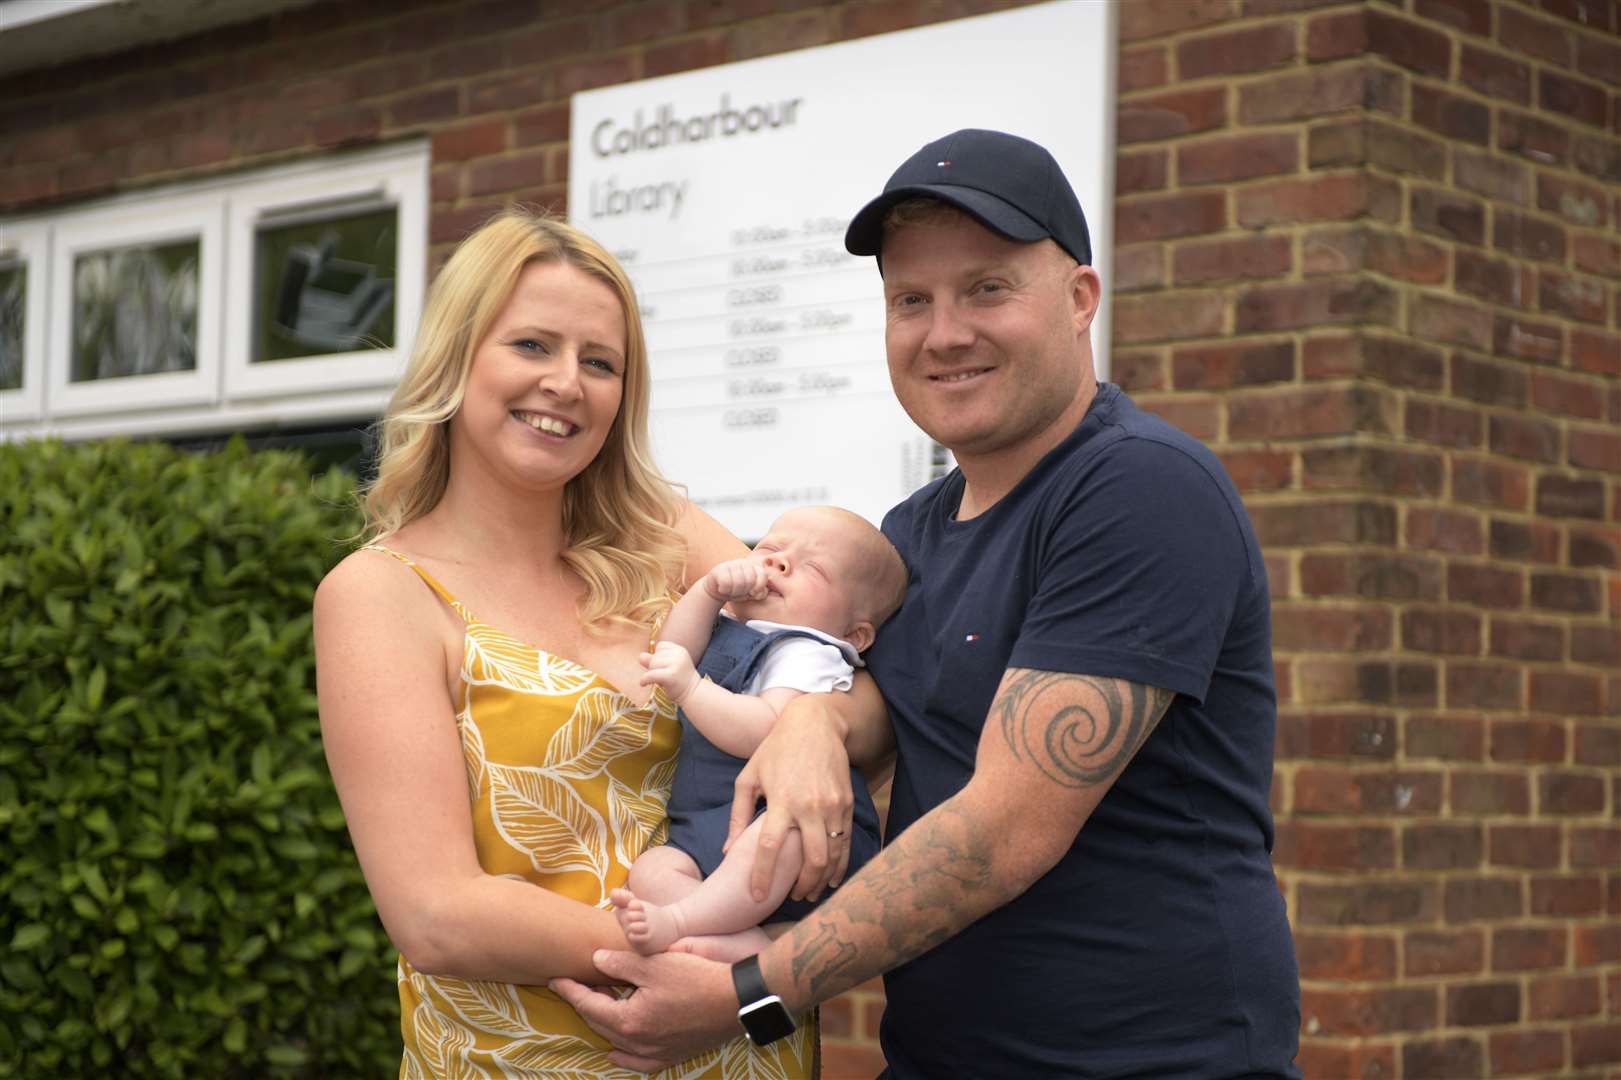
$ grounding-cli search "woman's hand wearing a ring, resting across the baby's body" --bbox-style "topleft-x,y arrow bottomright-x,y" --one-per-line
726,694 -> 854,900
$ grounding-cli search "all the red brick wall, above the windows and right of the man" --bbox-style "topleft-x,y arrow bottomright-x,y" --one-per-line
0,0 -> 1621,1078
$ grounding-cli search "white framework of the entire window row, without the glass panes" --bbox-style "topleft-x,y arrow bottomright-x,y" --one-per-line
0,139 -> 431,441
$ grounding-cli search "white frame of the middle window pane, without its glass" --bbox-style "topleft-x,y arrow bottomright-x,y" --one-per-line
45,198 -> 225,415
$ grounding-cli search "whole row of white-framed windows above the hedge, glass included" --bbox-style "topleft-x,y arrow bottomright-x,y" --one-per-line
0,143 -> 428,438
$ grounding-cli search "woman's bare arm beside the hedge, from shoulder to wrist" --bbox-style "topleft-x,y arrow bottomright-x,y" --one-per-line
314,553 -> 627,983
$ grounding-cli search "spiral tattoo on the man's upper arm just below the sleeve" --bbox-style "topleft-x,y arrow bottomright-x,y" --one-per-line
990,668 -> 1172,788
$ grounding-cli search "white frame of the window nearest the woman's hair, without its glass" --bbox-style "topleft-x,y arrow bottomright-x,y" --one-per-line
225,148 -> 428,399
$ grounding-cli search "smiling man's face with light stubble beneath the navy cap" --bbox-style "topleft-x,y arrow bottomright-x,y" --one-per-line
883,214 -> 1097,464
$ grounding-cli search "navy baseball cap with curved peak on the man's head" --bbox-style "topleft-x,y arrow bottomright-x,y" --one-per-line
845,128 -> 1093,268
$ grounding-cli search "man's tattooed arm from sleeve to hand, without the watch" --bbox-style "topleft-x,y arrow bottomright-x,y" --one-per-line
553,668 -> 1172,1067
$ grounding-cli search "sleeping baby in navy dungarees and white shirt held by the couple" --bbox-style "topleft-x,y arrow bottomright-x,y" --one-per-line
611,506 -> 906,960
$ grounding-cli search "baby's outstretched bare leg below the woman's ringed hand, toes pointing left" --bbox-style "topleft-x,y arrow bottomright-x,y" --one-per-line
614,821 -> 804,954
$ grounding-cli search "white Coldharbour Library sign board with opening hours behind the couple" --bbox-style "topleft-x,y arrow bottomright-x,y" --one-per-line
569,0 -> 1115,538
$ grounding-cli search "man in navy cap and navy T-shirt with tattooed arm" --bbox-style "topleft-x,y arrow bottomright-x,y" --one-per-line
559,130 -> 1300,1078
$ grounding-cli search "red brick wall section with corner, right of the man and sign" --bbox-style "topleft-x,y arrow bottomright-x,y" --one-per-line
1114,0 -> 1621,1077
